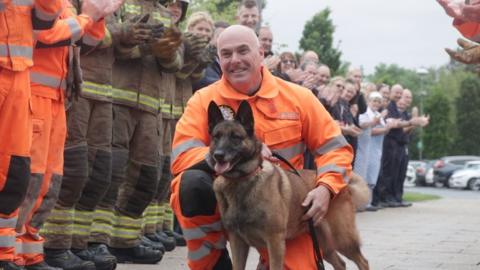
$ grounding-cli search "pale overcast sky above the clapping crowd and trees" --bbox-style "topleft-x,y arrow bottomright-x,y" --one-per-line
262,0 -> 460,74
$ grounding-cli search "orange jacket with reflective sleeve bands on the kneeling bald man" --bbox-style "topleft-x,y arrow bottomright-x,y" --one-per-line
171,68 -> 353,196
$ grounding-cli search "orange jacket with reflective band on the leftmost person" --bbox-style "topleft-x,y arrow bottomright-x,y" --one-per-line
0,0 -> 63,71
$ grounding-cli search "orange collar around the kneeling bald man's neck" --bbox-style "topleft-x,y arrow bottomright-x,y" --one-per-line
218,67 -> 279,100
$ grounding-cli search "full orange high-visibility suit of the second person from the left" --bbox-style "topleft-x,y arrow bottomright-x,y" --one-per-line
15,0 -> 105,265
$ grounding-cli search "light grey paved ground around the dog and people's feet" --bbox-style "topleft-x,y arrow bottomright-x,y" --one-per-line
117,188 -> 480,270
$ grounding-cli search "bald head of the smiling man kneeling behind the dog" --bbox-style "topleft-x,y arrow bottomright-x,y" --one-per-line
217,25 -> 263,95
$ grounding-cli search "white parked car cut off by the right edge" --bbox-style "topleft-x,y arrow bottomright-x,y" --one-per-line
448,161 -> 480,190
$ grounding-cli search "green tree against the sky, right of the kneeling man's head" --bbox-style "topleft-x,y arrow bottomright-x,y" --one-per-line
300,8 -> 342,73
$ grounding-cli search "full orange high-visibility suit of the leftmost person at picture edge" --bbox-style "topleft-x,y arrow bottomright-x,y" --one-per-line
0,0 -> 62,261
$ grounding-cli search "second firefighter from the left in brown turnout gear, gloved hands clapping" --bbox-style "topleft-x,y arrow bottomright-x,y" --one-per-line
87,0 -> 182,263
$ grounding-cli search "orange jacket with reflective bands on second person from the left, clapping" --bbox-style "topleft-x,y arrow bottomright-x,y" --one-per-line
30,1 -> 105,100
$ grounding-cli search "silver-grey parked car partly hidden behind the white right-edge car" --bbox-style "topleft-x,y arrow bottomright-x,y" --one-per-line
433,156 -> 480,187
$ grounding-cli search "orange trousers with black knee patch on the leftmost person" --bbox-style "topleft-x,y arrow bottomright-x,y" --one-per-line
0,67 -> 32,261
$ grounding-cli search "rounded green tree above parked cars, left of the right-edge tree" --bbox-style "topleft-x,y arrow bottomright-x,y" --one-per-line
424,93 -> 454,159
